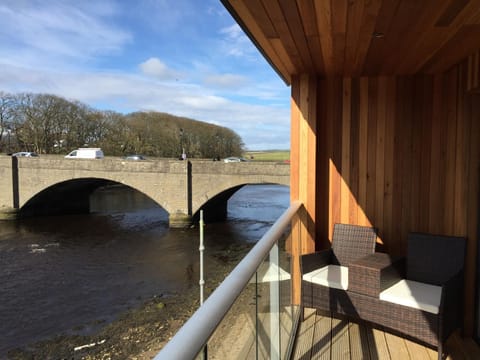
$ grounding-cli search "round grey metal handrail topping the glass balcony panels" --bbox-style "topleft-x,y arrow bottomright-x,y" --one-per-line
155,201 -> 302,360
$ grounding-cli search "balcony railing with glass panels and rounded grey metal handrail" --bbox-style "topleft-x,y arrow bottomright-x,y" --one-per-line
155,202 -> 301,360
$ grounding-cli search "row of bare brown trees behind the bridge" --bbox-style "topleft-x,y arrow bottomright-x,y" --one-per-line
0,92 -> 244,158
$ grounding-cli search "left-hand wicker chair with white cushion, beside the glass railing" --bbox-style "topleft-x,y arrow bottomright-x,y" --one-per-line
300,224 -> 377,314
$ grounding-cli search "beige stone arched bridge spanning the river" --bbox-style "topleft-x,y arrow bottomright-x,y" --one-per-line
0,156 -> 290,227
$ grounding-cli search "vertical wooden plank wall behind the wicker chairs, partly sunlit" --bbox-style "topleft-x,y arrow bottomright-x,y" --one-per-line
316,63 -> 480,329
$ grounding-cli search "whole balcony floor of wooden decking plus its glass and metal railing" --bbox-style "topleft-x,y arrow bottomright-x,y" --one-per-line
155,202 -> 480,360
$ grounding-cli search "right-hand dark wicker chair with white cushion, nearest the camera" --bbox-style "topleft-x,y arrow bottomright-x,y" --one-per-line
376,233 -> 466,359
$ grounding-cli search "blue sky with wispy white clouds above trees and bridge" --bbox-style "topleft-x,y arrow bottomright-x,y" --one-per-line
0,0 -> 290,150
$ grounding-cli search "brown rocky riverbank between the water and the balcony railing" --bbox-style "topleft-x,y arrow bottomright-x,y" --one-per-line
8,244 -> 250,360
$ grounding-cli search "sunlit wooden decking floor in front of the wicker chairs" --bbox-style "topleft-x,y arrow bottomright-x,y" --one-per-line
292,309 -> 480,360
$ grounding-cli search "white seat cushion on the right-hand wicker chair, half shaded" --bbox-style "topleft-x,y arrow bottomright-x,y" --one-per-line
380,279 -> 442,314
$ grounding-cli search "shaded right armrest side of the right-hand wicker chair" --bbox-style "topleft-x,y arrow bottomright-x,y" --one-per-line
439,271 -> 463,340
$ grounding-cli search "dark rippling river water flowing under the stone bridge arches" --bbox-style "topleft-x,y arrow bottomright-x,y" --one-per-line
0,185 -> 289,358
